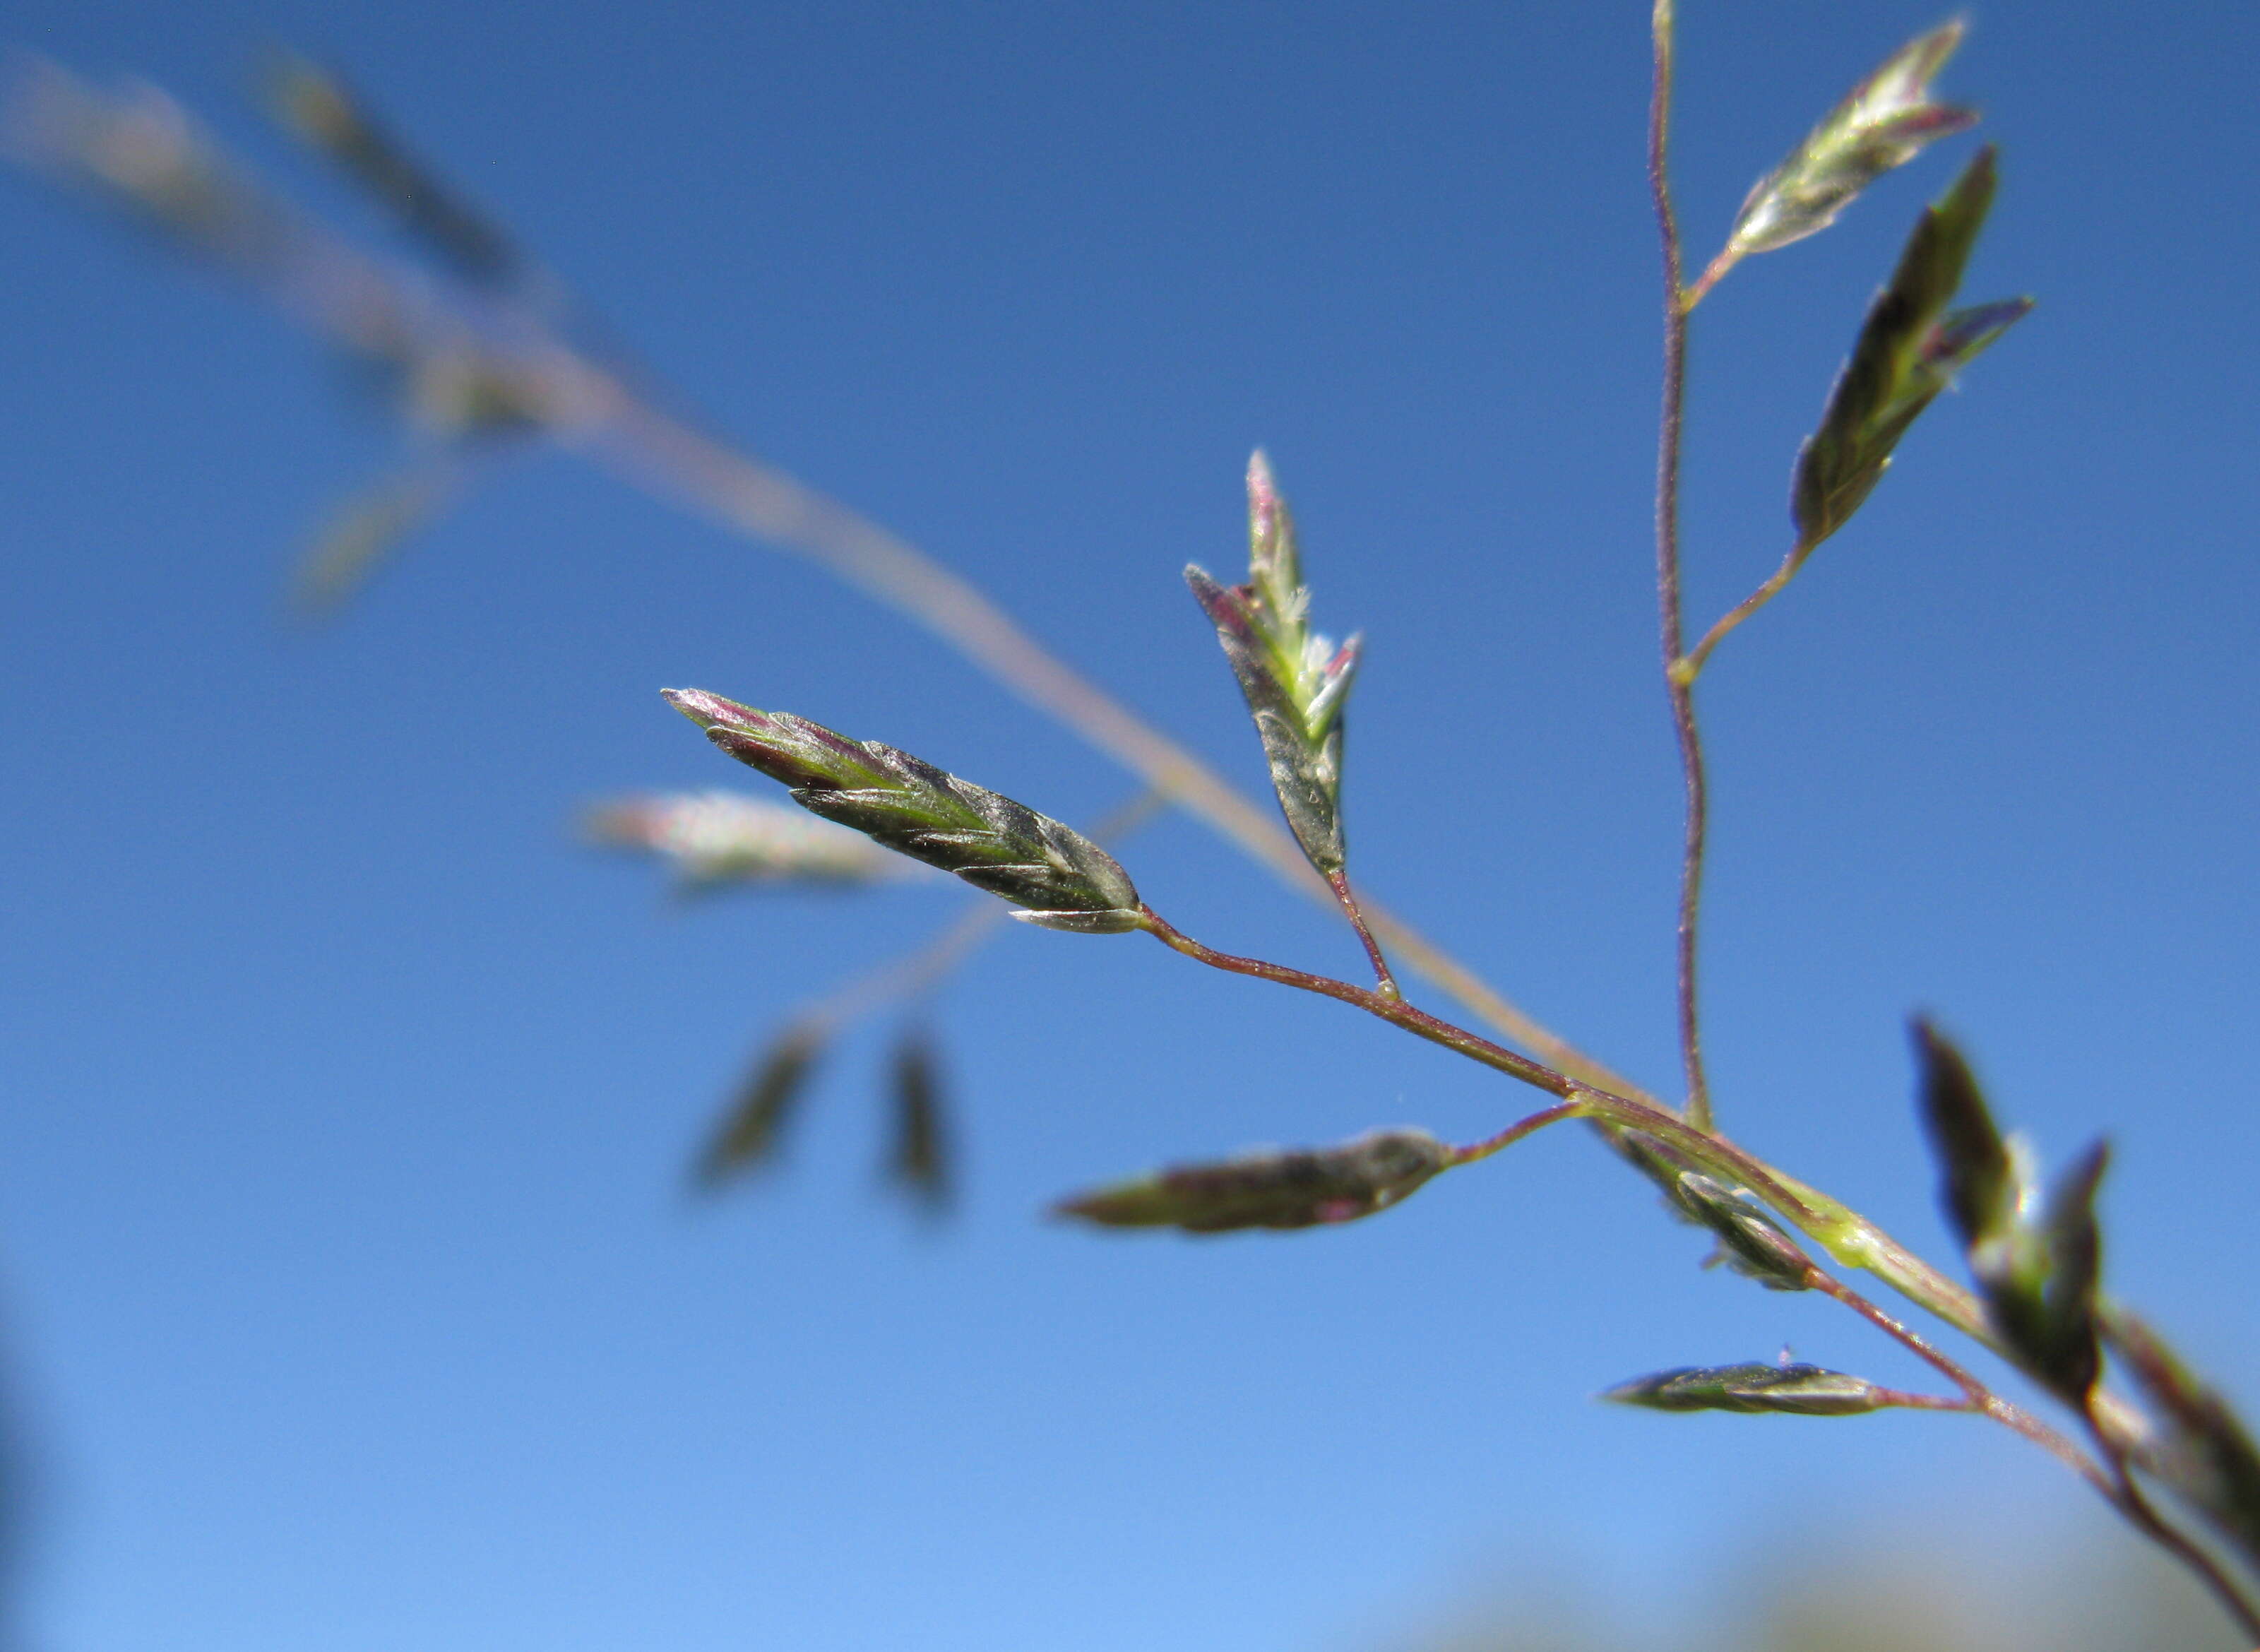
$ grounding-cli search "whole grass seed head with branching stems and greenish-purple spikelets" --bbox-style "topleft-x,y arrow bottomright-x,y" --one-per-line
11,0 -> 2260,1643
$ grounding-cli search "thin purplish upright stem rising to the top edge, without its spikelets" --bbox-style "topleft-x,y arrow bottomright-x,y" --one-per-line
1648,0 -> 1713,1130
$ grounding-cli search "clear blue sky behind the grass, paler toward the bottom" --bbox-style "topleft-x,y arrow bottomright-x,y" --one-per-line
0,0 -> 2260,1652
